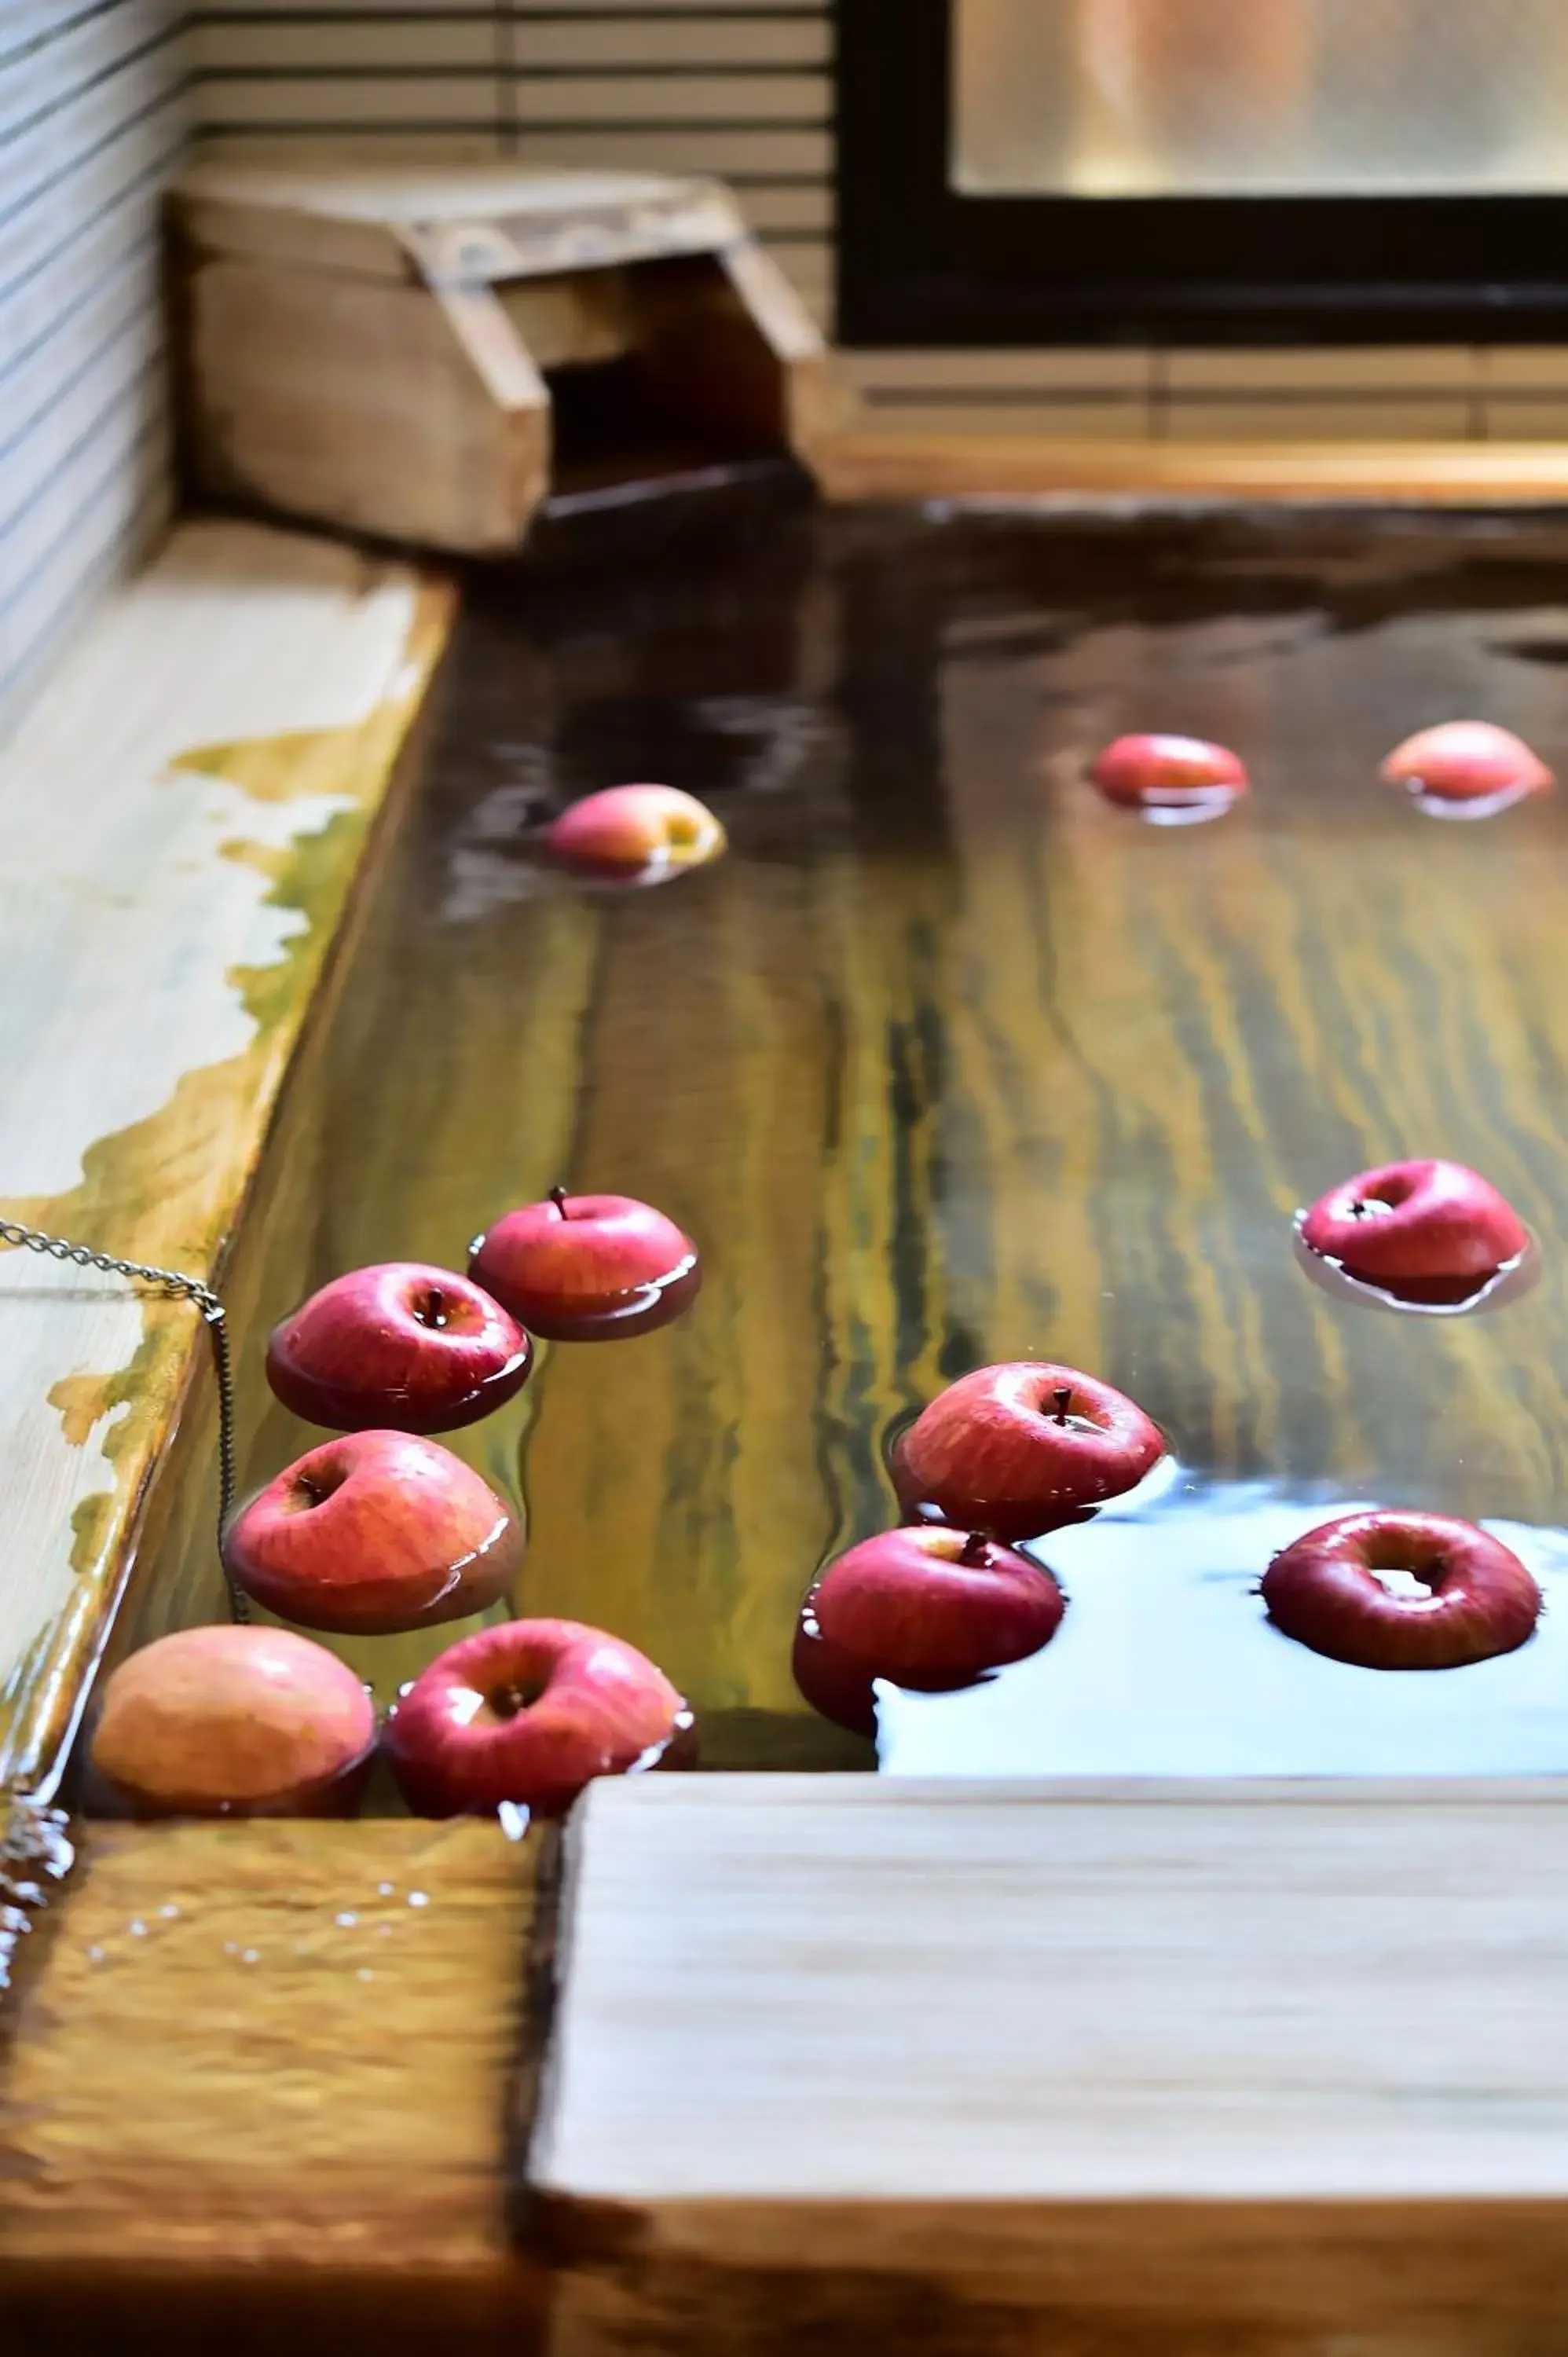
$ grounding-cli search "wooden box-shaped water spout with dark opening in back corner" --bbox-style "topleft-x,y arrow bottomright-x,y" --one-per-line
172,163 -> 828,556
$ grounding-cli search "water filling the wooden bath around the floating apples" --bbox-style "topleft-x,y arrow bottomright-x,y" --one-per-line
232,509 -> 1568,1775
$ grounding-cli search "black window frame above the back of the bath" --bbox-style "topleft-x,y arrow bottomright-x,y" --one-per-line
835,0 -> 1568,349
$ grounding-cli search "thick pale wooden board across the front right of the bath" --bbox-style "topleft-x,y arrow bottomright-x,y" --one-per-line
530,1777 -> 1568,2357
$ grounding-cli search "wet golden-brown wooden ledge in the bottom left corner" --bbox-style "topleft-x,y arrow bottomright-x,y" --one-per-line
0,1820 -> 544,2348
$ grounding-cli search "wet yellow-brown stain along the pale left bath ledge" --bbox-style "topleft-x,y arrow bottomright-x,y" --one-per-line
0,587 -> 450,1782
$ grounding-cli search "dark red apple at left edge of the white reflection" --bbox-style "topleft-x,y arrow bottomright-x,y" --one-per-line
795,1525 -> 1066,1735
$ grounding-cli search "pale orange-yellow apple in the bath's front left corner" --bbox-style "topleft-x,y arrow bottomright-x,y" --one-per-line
92,1626 -> 375,1817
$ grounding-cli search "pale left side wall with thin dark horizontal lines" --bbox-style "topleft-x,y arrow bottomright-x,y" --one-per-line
0,0 -> 186,726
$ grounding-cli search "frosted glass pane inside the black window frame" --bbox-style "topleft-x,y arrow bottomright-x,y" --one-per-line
953,0 -> 1568,196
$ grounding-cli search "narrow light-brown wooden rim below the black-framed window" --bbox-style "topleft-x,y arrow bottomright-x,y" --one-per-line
821,427 -> 1568,507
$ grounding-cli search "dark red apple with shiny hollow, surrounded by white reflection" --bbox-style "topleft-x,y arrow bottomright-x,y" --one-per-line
1262,1511 -> 1540,1669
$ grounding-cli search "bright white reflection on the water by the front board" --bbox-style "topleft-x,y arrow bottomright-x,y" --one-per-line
877,1473 -> 1568,1777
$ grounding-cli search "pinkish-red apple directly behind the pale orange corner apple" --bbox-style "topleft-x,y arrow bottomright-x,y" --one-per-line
224,1433 -> 523,1636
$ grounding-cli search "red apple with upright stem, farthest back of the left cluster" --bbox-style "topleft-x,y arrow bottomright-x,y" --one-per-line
469,1186 -> 702,1341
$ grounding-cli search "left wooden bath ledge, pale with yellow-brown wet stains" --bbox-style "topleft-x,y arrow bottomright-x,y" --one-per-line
0,523 -> 448,1787
